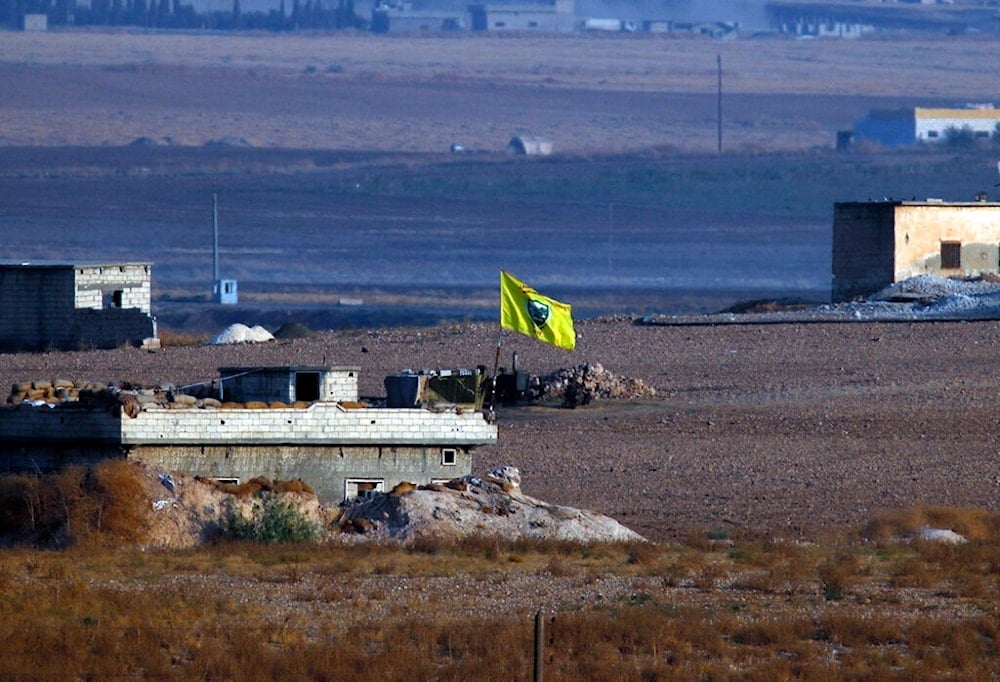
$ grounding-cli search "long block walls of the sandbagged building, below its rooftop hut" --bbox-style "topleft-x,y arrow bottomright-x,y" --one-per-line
0,403 -> 497,504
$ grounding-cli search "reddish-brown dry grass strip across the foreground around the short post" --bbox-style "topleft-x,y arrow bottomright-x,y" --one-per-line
0,516 -> 1000,680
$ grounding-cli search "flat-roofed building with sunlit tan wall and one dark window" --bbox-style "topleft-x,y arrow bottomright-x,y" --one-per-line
832,199 -> 1000,301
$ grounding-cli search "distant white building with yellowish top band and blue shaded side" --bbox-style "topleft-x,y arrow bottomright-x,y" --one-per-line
854,104 -> 1000,147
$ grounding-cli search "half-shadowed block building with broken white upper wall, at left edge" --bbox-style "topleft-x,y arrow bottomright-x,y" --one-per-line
0,261 -> 157,351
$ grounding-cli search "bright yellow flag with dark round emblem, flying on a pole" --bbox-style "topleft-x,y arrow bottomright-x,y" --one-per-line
500,270 -> 576,350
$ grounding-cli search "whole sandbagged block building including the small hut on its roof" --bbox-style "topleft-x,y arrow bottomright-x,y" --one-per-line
0,366 -> 497,504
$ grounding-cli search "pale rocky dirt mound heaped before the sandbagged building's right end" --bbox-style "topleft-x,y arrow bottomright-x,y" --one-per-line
340,466 -> 644,542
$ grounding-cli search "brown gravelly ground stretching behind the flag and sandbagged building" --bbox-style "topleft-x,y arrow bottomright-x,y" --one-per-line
0,317 -> 1000,541
